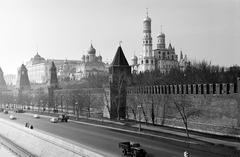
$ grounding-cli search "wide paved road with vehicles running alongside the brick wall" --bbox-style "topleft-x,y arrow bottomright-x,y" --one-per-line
0,113 -> 225,157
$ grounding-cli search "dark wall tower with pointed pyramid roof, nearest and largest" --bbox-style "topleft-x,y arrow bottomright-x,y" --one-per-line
109,46 -> 131,119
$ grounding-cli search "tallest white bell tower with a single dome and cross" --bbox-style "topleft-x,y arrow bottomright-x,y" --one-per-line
139,11 -> 155,72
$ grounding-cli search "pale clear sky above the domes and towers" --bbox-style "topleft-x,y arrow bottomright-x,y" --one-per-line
0,0 -> 240,74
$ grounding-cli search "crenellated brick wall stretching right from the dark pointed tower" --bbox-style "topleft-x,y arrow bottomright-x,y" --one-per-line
127,78 -> 240,136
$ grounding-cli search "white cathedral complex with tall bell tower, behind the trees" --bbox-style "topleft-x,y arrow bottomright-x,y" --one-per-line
131,13 -> 190,73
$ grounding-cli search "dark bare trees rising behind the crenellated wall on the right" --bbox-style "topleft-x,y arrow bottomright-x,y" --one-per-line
131,61 -> 240,85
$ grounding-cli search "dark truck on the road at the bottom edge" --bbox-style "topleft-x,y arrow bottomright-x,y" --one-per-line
118,142 -> 146,157
